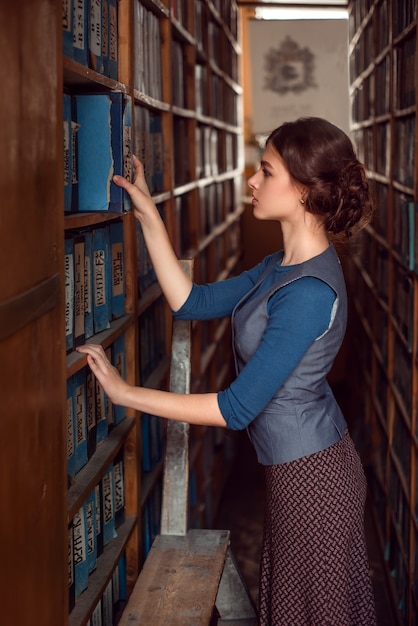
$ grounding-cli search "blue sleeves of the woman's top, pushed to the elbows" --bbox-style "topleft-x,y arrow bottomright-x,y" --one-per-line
173,252 -> 335,430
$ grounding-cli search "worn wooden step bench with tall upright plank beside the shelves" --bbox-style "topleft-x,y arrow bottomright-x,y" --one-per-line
119,261 -> 257,626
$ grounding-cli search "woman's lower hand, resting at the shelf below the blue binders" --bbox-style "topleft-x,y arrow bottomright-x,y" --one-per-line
76,344 -> 130,406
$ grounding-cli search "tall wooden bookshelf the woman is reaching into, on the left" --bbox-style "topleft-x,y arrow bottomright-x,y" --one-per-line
0,0 -> 243,626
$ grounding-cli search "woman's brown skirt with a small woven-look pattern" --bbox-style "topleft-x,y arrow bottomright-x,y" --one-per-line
260,434 -> 376,626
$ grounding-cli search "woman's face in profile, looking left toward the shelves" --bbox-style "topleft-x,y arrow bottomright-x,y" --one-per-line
248,144 -> 304,221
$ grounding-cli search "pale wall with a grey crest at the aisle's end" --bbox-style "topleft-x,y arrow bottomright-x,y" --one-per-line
249,20 -> 349,141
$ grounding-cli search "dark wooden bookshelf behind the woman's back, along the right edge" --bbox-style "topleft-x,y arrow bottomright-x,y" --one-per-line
347,0 -> 418,626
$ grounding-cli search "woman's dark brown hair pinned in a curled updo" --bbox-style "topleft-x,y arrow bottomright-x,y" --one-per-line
267,117 -> 373,238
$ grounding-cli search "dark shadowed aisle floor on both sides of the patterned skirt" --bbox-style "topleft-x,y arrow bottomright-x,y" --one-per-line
217,432 -> 399,626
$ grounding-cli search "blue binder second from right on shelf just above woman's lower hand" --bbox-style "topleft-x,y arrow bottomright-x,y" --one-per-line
92,226 -> 111,333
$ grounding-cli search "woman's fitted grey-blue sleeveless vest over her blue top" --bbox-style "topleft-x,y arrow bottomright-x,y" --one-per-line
232,245 -> 347,465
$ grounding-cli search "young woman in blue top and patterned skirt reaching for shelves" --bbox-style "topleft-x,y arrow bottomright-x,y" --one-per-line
79,118 -> 376,626
